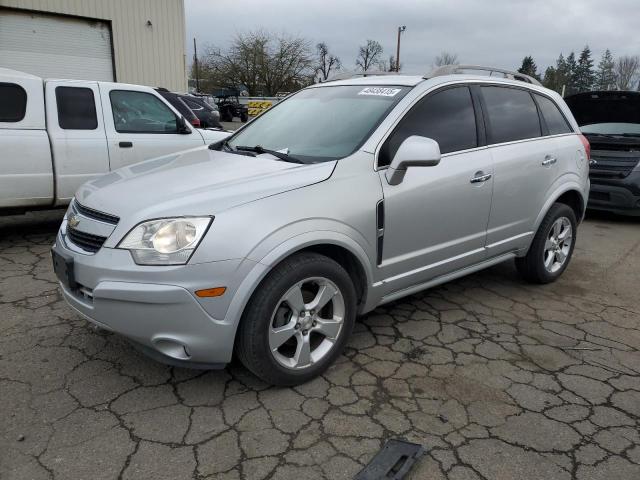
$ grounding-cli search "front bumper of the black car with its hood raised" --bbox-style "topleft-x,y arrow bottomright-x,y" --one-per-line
588,171 -> 640,215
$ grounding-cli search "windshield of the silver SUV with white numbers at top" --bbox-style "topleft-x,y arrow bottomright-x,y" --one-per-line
228,85 -> 409,162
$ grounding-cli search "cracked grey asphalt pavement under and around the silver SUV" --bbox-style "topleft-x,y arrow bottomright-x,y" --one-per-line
0,212 -> 640,480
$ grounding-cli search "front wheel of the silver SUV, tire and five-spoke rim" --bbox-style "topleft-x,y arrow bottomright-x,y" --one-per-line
236,253 -> 356,386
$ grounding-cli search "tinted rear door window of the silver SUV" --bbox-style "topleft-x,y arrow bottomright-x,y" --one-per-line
481,87 -> 542,143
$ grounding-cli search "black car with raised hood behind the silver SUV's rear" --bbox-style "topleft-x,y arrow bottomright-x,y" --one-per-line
566,91 -> 640,215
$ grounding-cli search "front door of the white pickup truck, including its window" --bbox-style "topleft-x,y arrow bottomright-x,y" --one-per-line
100,84 -> 204,170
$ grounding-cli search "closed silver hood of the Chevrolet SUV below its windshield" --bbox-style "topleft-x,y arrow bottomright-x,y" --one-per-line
76,147 -> 336,221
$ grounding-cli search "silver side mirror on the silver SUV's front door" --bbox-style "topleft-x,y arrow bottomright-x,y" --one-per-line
385,135 -> 440,185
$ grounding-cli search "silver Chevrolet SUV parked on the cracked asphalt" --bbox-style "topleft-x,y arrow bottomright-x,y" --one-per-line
52,65 -> 589,385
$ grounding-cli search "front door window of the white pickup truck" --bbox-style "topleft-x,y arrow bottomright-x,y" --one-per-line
109,90 -> 178,133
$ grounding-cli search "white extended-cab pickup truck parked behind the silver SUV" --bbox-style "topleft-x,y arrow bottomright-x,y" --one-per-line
0,68 -> 229,214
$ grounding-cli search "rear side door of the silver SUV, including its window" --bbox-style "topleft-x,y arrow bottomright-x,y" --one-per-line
480,85 -> 558,256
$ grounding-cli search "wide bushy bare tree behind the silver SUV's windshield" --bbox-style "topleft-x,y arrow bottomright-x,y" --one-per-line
200,30 -> 313,95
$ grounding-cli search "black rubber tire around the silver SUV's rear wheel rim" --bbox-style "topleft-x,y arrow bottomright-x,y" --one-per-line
516,203 -> 578,284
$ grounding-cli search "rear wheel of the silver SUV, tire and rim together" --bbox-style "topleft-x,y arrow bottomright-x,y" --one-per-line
516,203 -> 577,283
